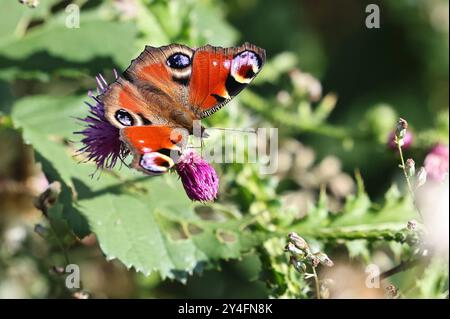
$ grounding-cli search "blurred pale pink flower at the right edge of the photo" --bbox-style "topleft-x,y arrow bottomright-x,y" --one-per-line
424,144 -> 449,182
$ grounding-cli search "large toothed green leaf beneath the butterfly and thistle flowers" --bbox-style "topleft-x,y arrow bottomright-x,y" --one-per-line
12,96 -> 261,280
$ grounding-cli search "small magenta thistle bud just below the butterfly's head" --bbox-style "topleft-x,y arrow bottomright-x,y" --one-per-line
175,150 -> 219,202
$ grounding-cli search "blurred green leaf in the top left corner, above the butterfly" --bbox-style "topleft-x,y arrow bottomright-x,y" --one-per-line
0,11 -> 137,80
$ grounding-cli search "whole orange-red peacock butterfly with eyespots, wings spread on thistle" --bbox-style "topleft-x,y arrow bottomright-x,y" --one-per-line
98,43 -> 265,175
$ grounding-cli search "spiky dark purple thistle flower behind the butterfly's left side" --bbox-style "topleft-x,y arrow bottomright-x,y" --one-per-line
74,72 -> 128,168
